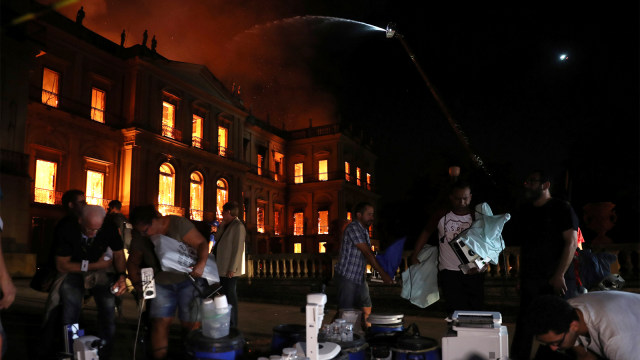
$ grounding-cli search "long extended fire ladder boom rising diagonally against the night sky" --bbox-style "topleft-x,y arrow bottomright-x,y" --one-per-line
386,22 -> 491,178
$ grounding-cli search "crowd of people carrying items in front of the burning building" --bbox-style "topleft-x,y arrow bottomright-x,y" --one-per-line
0,170 -> 640,359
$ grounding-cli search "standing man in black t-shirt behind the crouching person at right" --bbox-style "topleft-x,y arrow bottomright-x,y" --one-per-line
511,170 -> 578,359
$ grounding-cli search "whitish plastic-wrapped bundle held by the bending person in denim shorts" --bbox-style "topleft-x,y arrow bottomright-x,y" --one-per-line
151,234 -> 220,285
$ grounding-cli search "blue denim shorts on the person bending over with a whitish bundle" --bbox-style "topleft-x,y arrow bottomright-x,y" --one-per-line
149,279 -> 200,322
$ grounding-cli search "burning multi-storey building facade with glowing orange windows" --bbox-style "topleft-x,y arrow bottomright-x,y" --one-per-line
0,2 -> 377,272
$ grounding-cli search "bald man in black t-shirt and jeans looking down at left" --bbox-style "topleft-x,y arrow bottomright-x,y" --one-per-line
56,205 -> 126,359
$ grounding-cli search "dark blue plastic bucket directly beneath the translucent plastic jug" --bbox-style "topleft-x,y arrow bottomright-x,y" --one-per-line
185,328 -> 244,360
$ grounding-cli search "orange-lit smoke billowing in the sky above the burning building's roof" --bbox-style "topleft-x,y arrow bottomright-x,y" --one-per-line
41,0 -> 384,130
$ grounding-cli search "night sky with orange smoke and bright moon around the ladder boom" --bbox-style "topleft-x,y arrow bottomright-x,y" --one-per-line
42,0 -> 640,242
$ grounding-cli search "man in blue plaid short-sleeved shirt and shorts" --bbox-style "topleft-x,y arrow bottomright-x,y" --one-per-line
334,202 -> 393,321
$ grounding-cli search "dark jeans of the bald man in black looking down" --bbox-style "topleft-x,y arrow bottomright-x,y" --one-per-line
60,274 -> 116,359
